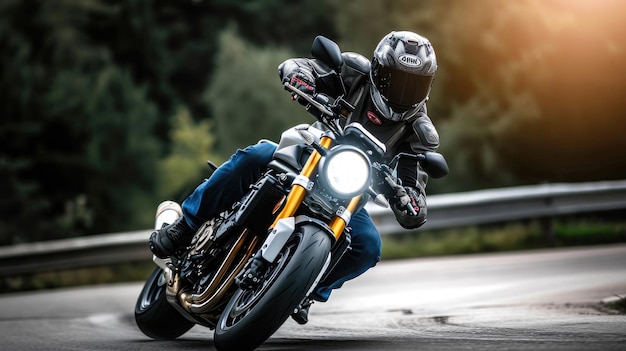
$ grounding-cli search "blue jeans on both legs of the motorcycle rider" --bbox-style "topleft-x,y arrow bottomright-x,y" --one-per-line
182,143 -> 382,301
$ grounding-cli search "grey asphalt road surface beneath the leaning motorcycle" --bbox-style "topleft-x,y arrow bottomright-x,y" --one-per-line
0,245 -> 626,351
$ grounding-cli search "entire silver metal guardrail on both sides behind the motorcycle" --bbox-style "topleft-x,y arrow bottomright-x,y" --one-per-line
0,180 -> 626,276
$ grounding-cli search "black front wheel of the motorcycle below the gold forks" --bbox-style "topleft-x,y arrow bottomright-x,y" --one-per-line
214,225 -> 331,351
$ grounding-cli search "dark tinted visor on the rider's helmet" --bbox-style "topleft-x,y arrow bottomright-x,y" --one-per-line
372,65 -> 433,112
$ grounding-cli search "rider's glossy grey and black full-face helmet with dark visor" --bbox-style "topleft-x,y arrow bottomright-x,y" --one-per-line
370,31 -> 437,121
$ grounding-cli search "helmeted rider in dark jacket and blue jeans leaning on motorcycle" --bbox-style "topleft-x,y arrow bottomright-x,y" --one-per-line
150,31 -> 439,324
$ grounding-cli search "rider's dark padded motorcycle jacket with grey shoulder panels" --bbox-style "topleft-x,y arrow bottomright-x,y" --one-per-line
278,52 -> 439,229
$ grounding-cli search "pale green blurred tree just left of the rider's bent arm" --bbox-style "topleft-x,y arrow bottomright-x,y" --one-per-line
206,29 -> 314,155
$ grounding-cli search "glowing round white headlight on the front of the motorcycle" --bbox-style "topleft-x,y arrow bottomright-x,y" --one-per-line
320,146 -> 371,197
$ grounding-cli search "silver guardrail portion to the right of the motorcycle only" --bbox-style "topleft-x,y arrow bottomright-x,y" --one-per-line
368,180 -> 626,234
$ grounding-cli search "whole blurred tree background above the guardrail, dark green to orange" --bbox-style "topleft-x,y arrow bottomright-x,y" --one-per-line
0,0 -> 626,245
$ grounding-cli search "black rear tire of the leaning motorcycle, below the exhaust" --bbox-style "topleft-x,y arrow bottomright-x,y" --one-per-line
135,267 -> 195,340
